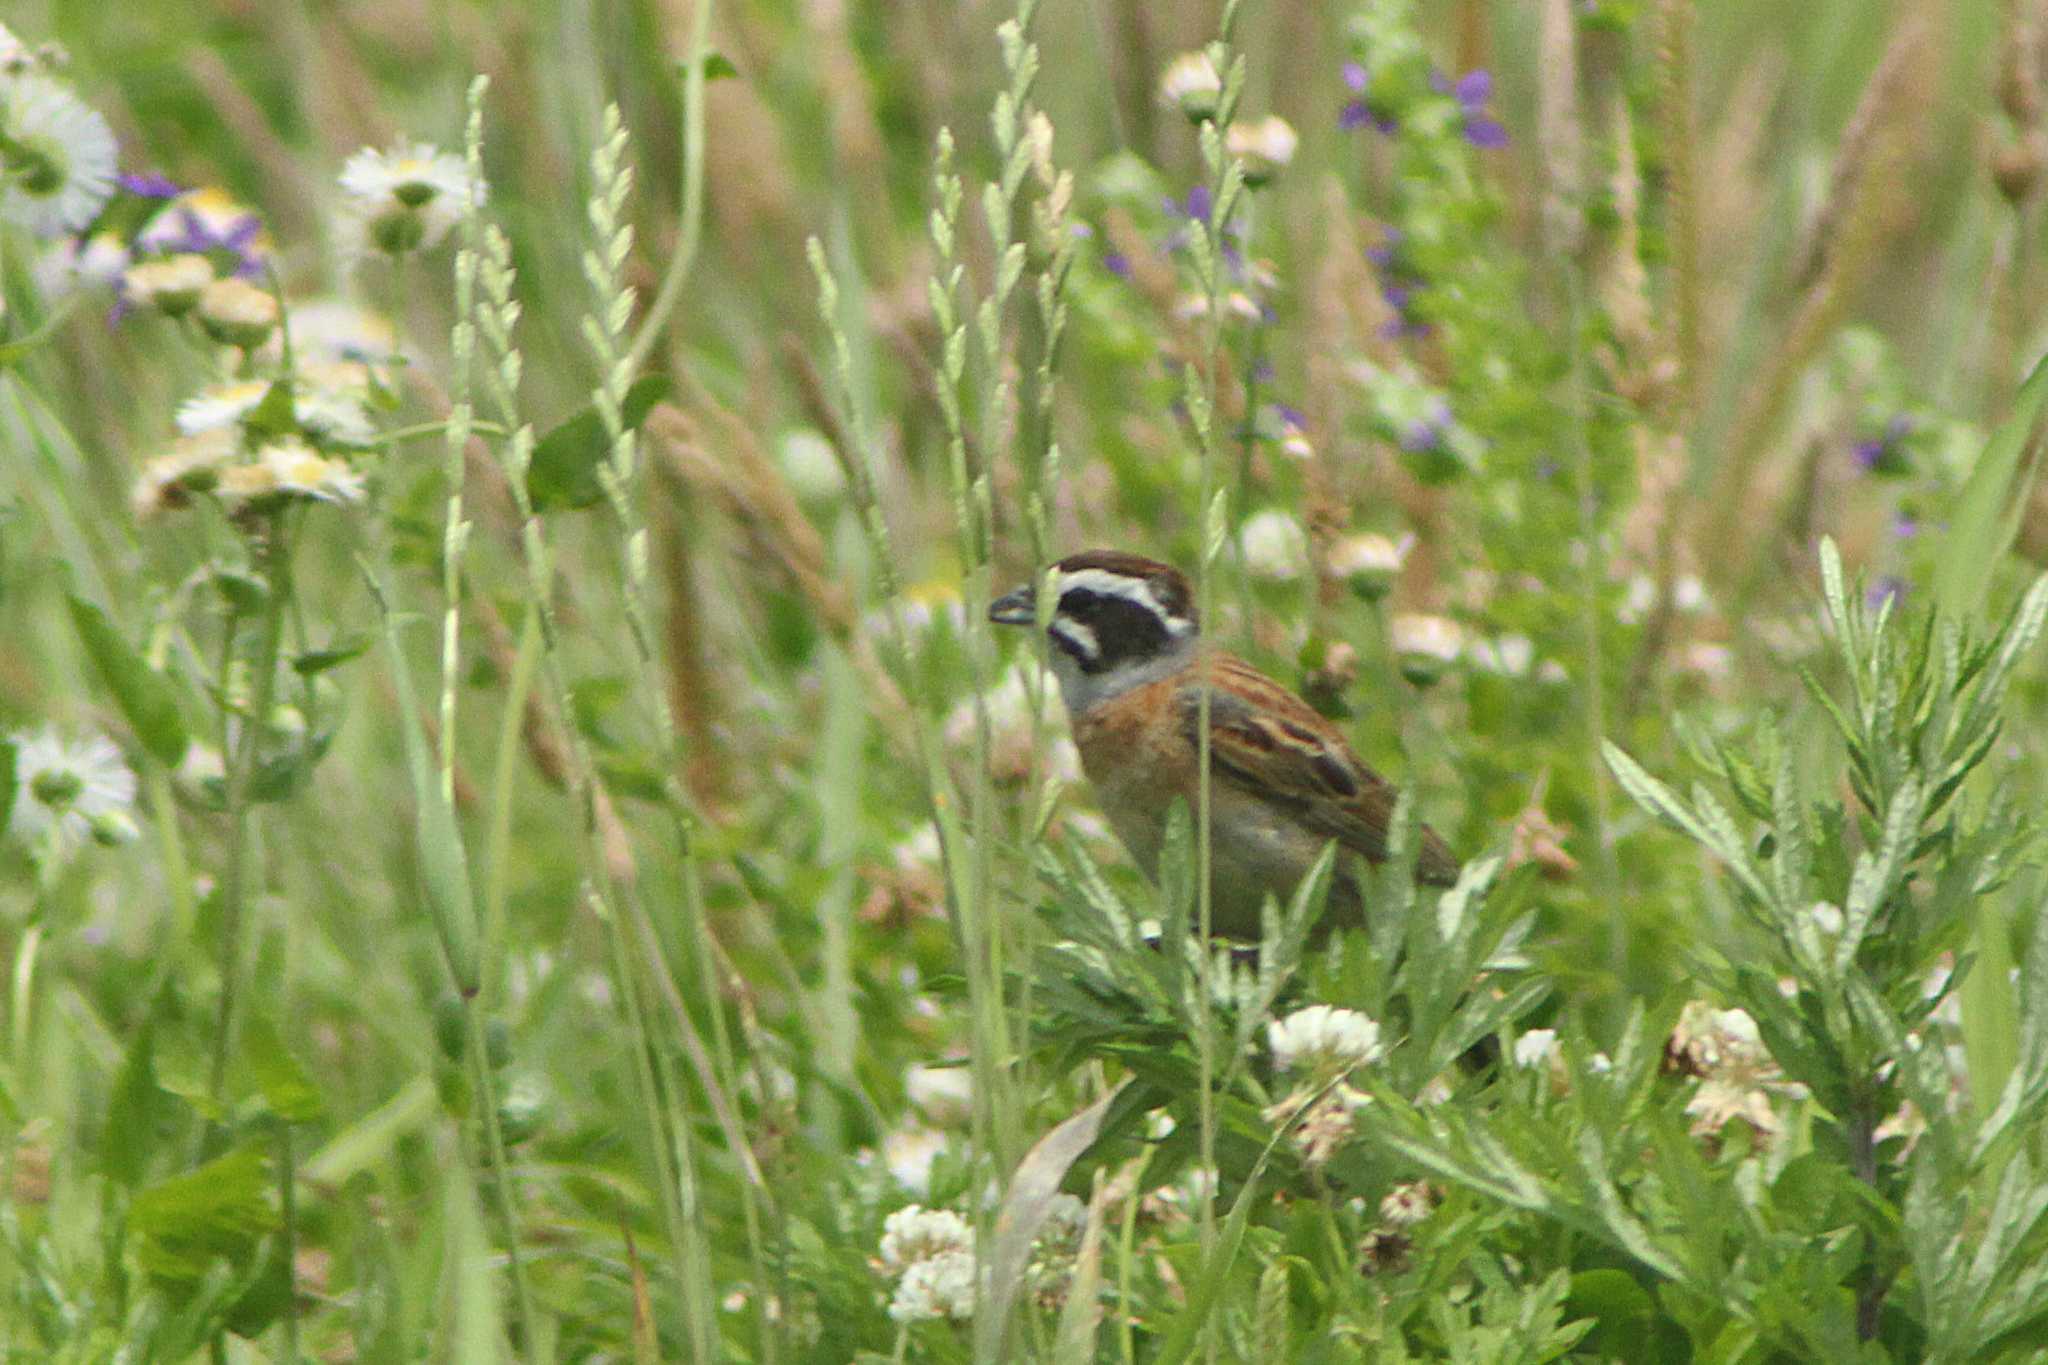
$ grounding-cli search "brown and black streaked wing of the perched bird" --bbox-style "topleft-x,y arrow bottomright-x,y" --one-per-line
1176,655 -> 1458,886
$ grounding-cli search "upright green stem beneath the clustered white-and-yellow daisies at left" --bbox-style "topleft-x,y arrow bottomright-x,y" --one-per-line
203,512 -> 291,1129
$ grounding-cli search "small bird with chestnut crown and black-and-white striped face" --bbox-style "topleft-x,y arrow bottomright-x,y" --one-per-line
989,551 -> 1458,937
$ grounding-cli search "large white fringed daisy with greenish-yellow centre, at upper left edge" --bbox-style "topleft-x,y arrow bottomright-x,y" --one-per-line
0,72 -> 119,237
